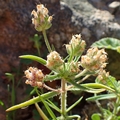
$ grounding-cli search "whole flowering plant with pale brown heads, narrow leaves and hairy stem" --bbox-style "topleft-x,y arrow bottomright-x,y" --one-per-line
6,4 -> 120,120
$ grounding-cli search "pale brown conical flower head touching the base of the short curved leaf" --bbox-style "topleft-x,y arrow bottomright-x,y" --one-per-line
46,51 -> 64,70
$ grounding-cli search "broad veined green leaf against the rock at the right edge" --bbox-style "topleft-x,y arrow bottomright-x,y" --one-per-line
92,37 -> 120,53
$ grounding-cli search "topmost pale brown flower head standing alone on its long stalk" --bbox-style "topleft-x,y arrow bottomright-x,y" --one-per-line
31,4 -> 52,31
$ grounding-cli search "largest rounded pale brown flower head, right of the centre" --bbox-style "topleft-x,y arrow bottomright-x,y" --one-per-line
81,47 -> 107,71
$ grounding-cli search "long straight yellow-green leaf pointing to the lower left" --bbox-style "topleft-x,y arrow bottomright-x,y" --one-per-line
6,91 -> 58,112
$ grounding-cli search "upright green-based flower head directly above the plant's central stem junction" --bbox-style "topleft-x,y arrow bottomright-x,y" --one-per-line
66,34 -> 86,56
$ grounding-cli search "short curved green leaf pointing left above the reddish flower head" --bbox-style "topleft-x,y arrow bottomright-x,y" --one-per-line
19,55 -> 46,65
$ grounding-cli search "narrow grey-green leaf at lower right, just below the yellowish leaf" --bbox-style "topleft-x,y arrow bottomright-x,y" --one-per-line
86,93 -> 117,101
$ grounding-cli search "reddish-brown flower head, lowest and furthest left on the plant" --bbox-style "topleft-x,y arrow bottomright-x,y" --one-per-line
25,67 -> 44,87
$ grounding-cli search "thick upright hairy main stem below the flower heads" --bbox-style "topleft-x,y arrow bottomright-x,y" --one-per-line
61,79 -> 67,119
